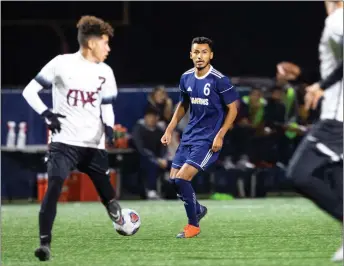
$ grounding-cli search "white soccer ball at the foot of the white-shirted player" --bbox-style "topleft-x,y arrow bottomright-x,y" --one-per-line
113,209 -> 141,236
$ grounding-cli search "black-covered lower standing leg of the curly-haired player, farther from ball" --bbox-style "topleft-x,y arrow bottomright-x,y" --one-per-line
39,177 -> 64,245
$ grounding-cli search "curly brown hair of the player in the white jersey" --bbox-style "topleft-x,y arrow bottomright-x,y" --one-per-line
76,16 -> 113,46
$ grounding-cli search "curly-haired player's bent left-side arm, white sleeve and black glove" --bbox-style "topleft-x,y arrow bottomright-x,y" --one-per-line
22,56 -> 65,133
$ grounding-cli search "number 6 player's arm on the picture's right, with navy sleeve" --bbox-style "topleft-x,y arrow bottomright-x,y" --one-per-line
212,77 -> 239,152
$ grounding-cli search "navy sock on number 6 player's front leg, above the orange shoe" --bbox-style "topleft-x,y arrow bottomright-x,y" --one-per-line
174,178 -> 198,226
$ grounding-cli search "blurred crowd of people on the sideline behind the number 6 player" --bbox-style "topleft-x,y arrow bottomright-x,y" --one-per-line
127,68 -> 321,199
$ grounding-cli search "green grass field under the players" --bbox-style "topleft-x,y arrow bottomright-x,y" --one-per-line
1,198 -> 341,266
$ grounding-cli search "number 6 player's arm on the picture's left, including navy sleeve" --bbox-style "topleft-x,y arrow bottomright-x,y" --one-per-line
161,79 -> 190,145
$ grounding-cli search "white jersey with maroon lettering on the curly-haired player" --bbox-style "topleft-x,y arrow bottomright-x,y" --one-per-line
36,52 -> 117,149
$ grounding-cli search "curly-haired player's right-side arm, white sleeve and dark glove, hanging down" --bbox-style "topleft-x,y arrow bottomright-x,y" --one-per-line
99,69 -> 118,146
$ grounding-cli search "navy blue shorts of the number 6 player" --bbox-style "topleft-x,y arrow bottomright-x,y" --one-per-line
172,143 -> 220,171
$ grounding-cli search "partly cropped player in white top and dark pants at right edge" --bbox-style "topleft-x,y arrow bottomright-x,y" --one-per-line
277,1 -> 343,261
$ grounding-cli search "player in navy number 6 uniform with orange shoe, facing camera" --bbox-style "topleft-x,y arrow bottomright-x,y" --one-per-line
161,37 -> 238,238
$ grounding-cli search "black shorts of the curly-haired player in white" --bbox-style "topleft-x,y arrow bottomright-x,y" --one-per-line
47,142 -> 109,179
